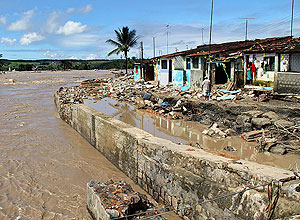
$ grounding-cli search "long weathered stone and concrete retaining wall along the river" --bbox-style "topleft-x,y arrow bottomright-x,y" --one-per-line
54,94 -> 300,219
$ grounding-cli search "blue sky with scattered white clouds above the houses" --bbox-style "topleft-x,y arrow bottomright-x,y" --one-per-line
0,0 -> 300,60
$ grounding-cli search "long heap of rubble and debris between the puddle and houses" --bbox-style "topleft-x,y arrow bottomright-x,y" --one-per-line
57,76 -> 300,153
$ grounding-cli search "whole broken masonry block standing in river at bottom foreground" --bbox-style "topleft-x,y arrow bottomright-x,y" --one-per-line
87,180 -> 164,220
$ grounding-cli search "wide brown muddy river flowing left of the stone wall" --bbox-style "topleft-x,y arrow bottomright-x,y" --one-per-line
0,72 -> 173,220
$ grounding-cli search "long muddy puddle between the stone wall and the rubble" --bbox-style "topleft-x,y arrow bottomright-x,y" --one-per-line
84,98 -> 300,169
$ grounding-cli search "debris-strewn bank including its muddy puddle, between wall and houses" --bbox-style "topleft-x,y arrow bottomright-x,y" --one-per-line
58,77 -> 300,169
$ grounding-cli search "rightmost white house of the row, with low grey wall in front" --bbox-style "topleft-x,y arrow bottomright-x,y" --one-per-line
244,37 -> 300,94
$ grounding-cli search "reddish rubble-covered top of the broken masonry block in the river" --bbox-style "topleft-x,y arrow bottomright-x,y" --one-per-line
88,180 -> 163,219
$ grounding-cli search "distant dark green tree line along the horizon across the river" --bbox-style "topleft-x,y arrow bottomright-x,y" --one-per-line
0,57 -> 139,71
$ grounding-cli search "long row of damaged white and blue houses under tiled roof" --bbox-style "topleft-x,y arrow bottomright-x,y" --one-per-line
149,37 -> 300,93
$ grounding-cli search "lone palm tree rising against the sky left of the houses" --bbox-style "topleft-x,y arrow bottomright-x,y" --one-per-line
106,26 -> 140,74
